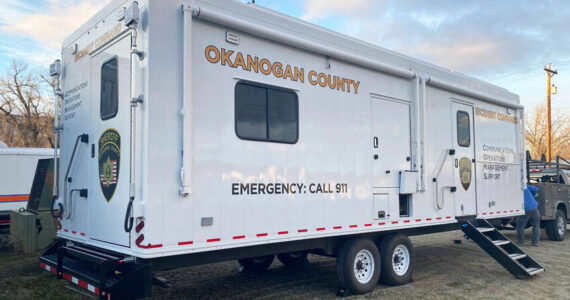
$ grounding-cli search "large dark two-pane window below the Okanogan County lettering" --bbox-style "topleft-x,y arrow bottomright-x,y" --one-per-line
235,82 -> 299,144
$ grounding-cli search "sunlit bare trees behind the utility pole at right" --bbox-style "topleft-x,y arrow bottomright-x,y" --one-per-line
525,105 -> 570,159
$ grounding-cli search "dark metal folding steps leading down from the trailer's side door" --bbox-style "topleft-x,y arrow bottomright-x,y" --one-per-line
460,219 -> 544,279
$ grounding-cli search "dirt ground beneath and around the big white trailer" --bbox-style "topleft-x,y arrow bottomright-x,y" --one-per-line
0,230 -> 570,299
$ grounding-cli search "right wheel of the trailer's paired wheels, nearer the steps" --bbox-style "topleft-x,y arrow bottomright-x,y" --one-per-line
378,234 -> 415,286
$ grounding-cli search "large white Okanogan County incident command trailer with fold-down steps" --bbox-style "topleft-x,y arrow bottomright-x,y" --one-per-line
40,0 -> 543,298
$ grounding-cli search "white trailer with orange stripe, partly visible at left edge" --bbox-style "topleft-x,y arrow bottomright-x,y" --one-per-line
0,143 -> 53,225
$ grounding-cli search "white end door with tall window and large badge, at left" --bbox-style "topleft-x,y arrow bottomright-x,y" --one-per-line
88,35 -> 131,247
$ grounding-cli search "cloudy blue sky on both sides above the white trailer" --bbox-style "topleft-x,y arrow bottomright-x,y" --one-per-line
0,0 -> 570,113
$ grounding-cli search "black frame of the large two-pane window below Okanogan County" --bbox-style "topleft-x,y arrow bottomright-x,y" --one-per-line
234,80 -> 300,145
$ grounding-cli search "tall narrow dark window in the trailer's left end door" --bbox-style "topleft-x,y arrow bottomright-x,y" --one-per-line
101,57 -> 119,120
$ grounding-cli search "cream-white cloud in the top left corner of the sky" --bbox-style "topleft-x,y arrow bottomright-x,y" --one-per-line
0,0 -> 108,49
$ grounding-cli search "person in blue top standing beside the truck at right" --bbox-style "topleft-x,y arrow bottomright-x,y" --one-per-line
517,185 -> 540,246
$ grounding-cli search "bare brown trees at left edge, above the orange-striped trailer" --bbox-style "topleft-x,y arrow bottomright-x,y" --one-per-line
0,61 -> 54,147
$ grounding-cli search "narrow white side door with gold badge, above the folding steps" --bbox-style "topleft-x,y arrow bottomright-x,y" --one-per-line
451,102 -> 477,216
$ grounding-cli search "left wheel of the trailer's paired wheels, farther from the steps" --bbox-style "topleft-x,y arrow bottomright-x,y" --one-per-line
336,238 -> 381,294
